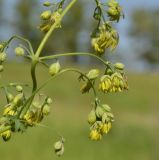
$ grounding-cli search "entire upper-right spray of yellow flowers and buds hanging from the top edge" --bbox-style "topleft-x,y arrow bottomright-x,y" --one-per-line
91,0 -> 124,56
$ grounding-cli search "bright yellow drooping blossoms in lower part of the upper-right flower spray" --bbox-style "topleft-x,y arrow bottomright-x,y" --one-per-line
92,23 -> 119,55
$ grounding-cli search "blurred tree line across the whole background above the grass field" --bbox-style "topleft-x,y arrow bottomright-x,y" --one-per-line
0,0 -> 159,66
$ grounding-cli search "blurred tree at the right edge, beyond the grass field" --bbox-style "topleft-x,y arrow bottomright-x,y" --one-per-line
129,8 -> 159,67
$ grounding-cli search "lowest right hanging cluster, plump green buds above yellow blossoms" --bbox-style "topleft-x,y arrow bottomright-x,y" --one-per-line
88,104 -> 114,140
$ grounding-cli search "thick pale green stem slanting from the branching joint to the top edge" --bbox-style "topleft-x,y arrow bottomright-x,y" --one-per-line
35,0 -> 77,58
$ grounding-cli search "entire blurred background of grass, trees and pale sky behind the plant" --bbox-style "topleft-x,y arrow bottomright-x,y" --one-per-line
0,0 -> 159,160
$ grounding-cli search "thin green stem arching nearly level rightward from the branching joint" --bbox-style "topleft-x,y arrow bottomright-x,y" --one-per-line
40,52 -> 110,66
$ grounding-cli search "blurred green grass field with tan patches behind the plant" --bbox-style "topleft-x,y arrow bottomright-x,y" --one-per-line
0,63 -> 159,160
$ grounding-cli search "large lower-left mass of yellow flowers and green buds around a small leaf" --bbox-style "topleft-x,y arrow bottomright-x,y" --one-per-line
0,83 -> 52,141
